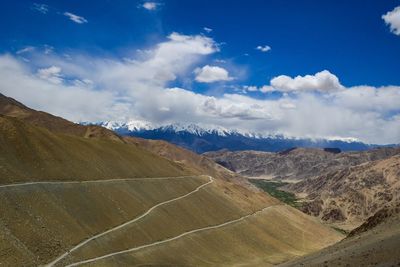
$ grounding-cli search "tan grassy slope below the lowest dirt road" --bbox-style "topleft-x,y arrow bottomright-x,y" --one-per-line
68,206 -> 338,266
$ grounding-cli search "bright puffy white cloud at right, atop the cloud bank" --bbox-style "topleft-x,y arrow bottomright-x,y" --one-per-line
271,70 -> 344,92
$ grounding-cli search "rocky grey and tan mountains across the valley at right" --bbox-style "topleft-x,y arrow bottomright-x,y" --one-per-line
204,147 -> 400,230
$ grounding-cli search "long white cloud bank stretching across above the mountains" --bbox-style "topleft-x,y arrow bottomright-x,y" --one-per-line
0,33 -> 400,144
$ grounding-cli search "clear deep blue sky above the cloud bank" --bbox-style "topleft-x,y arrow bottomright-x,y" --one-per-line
0,0 -> 400,86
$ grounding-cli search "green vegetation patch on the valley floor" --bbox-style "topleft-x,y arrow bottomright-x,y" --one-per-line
249,179 -> 301,208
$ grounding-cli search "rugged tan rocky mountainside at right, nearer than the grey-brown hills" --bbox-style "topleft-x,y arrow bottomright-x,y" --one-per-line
286,155 -> 400,229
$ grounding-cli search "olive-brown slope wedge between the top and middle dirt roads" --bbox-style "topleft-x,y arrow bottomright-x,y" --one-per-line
0,177 -> 208,266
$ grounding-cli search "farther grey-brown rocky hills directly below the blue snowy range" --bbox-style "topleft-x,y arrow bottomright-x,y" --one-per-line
204,148 -> 400,180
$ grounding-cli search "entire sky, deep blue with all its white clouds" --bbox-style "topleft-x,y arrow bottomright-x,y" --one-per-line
0,0 -> 400,144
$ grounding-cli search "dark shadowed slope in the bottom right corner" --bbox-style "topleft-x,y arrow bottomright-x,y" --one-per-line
279,206 -> 400,267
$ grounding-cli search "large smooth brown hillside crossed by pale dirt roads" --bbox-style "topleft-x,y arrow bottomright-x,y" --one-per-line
0,95 -> 342,266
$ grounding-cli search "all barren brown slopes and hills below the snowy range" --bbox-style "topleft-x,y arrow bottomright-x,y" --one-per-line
0,95 -> 400,266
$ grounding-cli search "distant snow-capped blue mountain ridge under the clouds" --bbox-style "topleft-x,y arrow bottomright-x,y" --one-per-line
87,120 -> 384,153
